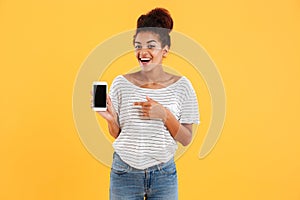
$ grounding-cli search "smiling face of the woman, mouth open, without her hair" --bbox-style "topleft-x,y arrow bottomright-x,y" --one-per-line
134,32 -> 168,71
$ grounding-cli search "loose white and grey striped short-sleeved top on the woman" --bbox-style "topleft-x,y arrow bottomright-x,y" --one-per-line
110,75 -> 199,169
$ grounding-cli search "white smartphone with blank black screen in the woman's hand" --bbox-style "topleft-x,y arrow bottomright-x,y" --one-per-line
93,81 -> 107,111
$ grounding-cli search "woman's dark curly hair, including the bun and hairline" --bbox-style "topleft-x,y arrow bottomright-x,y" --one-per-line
133,8 -> 173,47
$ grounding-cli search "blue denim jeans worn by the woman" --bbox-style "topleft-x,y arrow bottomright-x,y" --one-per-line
109,153 -> 178,200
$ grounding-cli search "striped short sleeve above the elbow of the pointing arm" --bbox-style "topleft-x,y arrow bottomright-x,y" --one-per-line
179,79 -> 200,124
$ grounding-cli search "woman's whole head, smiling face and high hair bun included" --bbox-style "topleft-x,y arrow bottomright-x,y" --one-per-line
133,8 -> 173,74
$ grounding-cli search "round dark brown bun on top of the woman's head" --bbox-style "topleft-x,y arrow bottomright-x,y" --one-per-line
137,8 -> 173,32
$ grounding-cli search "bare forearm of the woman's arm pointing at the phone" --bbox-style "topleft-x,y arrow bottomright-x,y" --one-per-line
164,109 -> 192,146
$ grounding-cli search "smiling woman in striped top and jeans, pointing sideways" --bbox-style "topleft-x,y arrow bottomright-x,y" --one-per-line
98,8 -> 199,200
